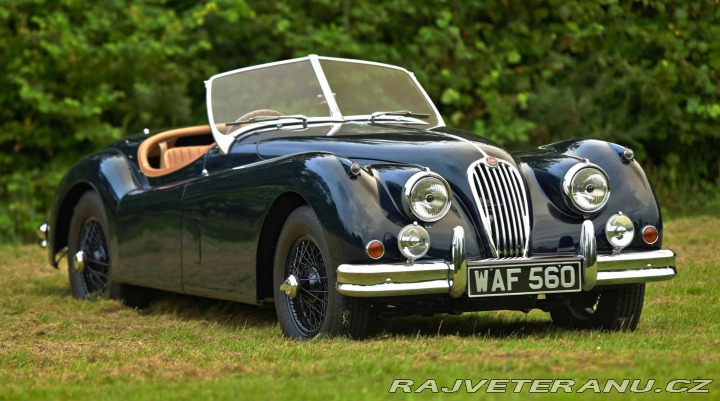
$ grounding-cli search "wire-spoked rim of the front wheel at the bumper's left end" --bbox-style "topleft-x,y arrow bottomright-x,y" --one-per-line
285,235 -> 328,337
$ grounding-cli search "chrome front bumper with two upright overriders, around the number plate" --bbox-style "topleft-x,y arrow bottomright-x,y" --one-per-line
337,220 -> 676,298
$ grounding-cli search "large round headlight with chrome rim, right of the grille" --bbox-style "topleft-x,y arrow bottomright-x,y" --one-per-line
563,164 -> 610,212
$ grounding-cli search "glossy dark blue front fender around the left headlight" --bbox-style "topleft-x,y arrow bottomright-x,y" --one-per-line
290,154 -> 479,264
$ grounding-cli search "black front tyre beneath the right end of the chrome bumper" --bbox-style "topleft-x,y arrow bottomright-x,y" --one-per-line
550,283 -> 645,331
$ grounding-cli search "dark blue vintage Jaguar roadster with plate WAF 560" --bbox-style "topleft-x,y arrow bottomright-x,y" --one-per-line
39,55 -> 676,339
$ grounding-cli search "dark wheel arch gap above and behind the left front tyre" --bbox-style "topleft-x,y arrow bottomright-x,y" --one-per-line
255,191 -> 308,300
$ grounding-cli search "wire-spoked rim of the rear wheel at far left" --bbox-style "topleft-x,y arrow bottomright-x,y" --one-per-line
78,218 -> 110,299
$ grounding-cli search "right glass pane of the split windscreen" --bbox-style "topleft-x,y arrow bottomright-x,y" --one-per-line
320,59 -> 438,127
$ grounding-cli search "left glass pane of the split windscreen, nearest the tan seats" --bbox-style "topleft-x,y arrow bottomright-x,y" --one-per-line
210,60 -> 330,124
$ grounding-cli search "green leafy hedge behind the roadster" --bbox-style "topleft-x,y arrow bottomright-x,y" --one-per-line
0,0 -> 720,242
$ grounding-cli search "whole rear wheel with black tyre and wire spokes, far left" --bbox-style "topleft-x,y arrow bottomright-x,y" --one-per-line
68,191 -> 120,300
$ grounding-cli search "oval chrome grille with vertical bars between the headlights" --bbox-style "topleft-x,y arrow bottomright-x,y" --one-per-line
468,159 -> 530,258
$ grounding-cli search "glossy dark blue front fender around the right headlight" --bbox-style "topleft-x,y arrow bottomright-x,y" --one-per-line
516,140 -> 662,254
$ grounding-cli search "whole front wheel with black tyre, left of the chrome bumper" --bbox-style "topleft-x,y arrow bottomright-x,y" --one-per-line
273,206 -> 370,340
